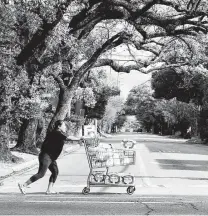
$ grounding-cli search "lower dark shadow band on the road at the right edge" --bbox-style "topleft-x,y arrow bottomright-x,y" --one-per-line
156,159 -> 208,171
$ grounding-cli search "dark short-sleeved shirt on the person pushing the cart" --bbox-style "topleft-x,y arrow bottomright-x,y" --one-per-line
41,131 -> 67,160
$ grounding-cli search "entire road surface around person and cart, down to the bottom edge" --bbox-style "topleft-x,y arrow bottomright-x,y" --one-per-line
0,133 -> 208,215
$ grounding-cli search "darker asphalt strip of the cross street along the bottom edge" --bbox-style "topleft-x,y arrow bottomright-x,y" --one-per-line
0,193 -> 208,215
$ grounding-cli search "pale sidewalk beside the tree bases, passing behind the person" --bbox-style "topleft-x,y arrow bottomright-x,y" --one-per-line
0,144 -> 80,186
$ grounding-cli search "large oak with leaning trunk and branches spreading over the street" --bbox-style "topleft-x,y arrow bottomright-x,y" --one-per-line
1,0 -> 208,159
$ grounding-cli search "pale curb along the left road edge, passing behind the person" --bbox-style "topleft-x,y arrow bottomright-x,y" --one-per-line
0,144 -> 80,186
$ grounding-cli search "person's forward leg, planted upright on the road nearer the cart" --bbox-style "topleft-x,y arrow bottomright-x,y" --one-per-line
46,161 -> 59,194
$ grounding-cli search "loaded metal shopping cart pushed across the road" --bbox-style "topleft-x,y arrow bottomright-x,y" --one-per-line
82,138 -> 136,195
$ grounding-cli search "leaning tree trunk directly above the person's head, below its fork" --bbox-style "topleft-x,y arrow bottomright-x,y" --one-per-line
47,88 -> 73,133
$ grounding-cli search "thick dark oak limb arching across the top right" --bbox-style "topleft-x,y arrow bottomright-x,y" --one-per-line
70,0 -> 207,40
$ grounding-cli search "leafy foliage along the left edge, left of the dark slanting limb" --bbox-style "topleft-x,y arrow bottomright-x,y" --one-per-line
0,1 -> 59,136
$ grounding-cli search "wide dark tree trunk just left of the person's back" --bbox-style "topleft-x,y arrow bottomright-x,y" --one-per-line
12,118 -> 38,155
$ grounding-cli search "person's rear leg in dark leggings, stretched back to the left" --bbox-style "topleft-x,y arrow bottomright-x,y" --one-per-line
18,153 -> 52,194
